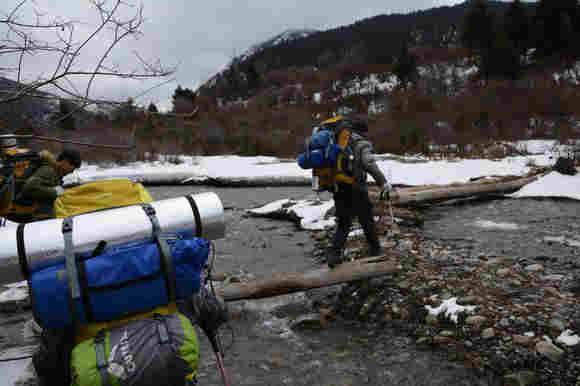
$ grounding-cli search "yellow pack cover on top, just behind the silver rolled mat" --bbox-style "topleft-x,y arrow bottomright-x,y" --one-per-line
54,179 -> 153,218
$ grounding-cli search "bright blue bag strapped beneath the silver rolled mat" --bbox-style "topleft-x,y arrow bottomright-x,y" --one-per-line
28,236 -> 210,328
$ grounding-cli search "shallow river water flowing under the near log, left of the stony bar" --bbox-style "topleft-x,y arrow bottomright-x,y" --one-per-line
148,187 -> 489,386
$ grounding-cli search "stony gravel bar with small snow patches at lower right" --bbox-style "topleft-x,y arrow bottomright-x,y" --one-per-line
312,192 -> 580,386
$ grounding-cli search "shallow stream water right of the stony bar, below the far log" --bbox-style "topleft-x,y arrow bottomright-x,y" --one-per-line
424,199 -> 580,263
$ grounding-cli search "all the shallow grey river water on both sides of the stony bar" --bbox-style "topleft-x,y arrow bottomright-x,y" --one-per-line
3,186 -> 580,386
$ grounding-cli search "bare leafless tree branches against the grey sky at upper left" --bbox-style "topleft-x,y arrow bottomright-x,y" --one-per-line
0,0 -> 174,108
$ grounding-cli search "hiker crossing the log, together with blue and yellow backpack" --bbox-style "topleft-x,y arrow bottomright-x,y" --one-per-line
298,117 -> 391,268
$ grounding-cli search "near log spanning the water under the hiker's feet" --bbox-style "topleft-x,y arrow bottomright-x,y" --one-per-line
216,254 -> 402,301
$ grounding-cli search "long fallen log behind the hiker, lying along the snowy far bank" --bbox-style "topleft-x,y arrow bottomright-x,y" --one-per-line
371,175 -> 539,205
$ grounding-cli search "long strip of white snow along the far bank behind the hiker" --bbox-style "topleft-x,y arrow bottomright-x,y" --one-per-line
65,146 -> 554,186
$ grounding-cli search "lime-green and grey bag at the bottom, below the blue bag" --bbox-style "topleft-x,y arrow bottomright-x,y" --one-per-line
70,313 -> 199,386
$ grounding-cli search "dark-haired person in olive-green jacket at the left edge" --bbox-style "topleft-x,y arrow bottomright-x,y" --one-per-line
13,150 -> 81,222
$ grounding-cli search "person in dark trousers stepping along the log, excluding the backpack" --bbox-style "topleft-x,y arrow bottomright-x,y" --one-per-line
326,120 -> 391,268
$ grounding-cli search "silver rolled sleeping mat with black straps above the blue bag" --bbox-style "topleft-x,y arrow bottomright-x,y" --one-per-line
0,192 -> 225,278
